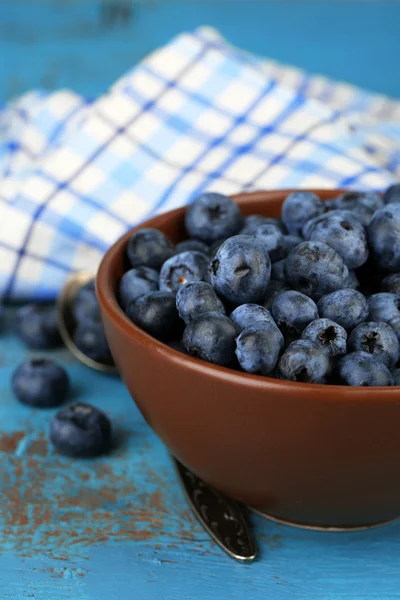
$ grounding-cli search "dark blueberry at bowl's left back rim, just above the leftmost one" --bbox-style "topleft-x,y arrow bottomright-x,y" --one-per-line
126,229 -> 174,270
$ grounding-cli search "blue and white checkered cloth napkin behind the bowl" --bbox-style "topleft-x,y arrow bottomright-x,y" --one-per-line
0,28 -> 400,300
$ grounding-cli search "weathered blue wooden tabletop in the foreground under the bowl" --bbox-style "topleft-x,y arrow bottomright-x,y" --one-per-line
0,314 -> 400,600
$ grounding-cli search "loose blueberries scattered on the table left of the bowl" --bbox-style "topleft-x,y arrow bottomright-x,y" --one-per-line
12,302 -> 111,458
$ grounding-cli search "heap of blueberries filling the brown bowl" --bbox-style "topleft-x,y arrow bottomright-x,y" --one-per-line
119,185 -> 400,386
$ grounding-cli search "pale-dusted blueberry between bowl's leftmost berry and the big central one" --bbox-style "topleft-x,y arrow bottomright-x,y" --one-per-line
160,251 -> 210,292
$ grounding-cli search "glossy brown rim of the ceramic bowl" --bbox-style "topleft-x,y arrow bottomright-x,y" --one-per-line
96,189 -> 400,402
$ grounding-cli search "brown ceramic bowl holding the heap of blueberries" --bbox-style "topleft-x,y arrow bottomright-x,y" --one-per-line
97,190 -> 400,527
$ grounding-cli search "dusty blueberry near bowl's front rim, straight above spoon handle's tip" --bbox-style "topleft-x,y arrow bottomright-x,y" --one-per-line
236,323 -> 283,375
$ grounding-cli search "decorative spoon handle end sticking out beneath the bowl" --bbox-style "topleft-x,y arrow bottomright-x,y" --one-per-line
173,458 -> 257,561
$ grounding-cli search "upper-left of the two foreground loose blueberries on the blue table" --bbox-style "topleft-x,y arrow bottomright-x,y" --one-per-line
12,358 -> 70,408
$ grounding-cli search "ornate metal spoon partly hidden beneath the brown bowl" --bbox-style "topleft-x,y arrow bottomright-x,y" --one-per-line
57,273 -> 256,562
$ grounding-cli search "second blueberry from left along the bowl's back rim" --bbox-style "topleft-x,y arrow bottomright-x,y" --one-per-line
185,193 -> 243,244
